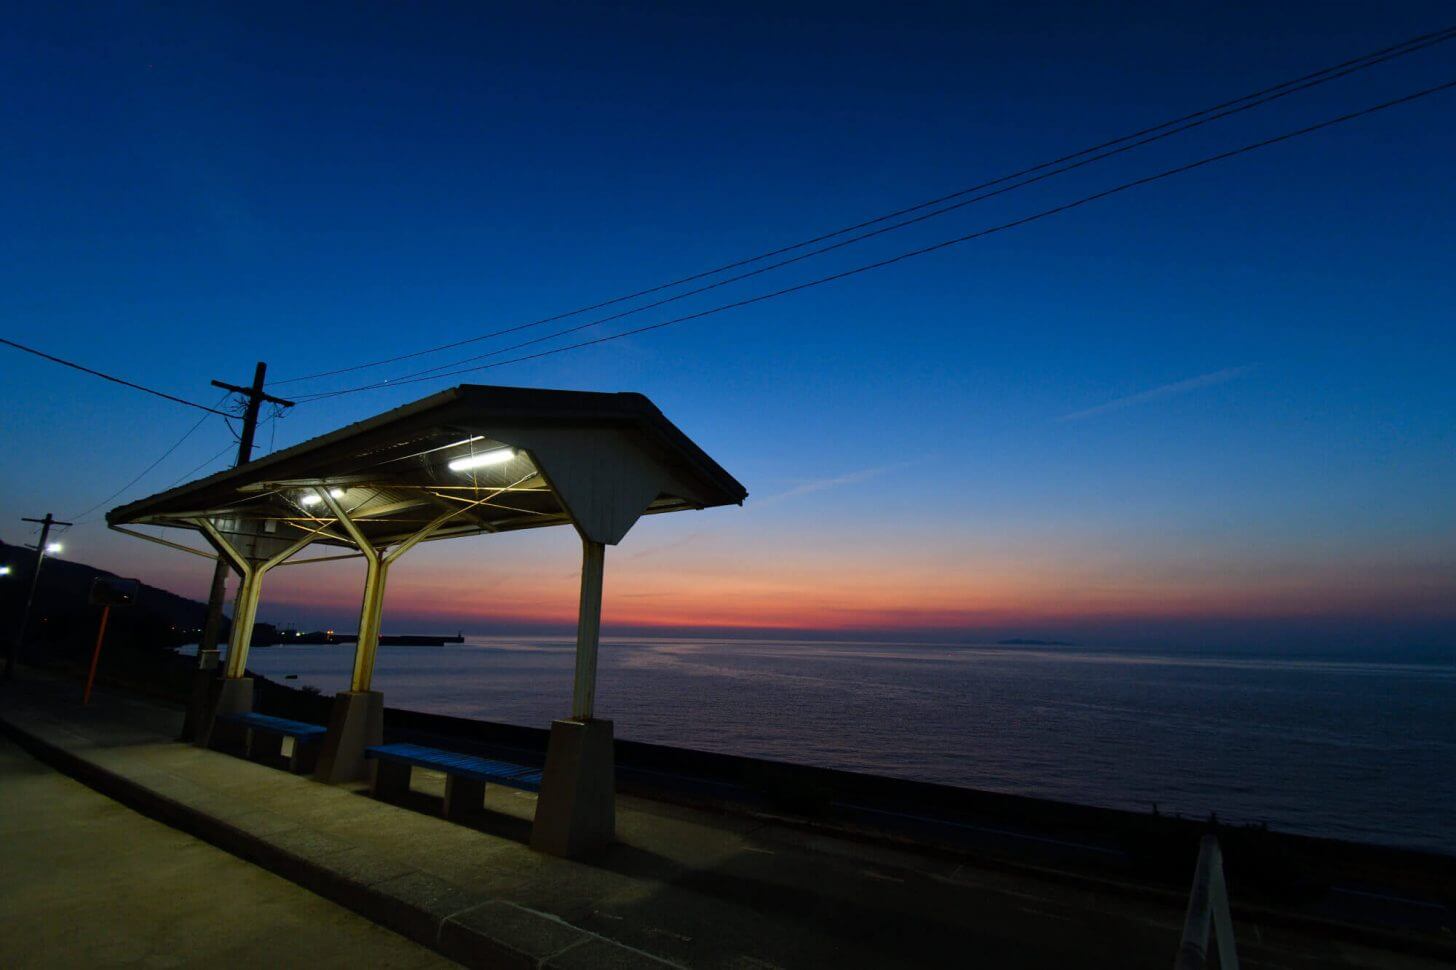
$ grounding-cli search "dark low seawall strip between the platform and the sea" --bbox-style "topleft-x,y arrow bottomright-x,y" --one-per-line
232,664 -> 1456,951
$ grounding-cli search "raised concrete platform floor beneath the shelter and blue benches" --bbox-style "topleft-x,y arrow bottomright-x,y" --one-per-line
0,677 -> 1443,970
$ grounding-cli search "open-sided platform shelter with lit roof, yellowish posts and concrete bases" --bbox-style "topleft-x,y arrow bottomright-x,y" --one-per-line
106,385 -> 747,855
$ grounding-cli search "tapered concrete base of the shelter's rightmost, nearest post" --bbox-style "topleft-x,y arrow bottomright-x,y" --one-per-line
531,719 -> 617,858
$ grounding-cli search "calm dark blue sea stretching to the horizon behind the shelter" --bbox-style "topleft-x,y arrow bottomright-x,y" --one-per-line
215,638 -> 1456,853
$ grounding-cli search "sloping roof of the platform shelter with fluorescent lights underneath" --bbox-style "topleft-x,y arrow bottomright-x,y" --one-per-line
106,385 -> 747,555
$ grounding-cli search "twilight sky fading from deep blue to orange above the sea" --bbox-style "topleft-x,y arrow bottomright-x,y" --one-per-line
0,3 -> 1456,647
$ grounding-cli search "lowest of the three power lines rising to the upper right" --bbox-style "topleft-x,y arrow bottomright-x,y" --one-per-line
301,80 -> 1456,401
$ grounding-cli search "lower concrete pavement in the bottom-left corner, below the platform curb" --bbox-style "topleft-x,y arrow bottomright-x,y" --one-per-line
0,737 -> 457,970
